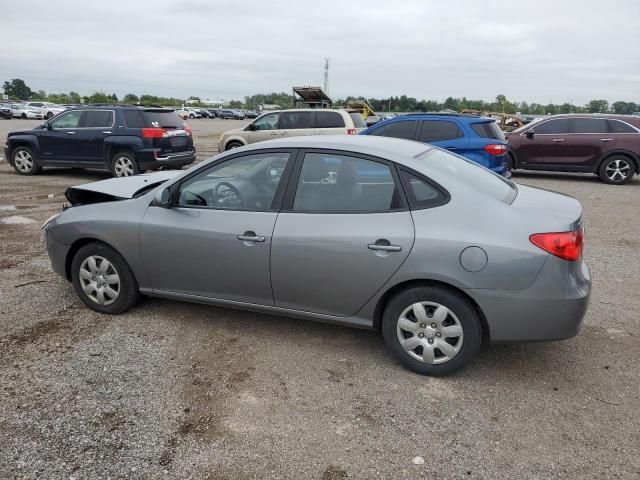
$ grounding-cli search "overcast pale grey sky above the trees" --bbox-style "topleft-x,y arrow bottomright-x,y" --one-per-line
0,0 -> 640,104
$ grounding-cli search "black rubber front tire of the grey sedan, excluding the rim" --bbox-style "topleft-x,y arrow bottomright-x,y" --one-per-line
71,242 -> 140,315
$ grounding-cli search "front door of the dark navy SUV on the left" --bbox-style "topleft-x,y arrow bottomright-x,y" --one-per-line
38,110 -> 84,163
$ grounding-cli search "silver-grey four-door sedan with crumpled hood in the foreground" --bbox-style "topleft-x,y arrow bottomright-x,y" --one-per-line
43,136 -> 591,375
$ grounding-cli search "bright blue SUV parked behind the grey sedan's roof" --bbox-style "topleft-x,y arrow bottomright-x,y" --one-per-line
360,113 -> 508,176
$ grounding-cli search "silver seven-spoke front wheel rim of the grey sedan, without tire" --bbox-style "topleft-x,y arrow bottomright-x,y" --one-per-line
79,255 -> 120,305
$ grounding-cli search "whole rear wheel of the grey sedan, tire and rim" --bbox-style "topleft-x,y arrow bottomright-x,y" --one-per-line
382,287 -> 482,376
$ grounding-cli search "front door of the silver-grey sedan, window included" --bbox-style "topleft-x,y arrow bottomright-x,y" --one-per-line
140,151 -> 291,305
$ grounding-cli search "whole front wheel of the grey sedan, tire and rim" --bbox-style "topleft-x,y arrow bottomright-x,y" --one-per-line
71,242 -> 140,314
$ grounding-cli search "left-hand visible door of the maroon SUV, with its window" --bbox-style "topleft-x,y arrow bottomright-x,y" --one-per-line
515,118 -> 571,168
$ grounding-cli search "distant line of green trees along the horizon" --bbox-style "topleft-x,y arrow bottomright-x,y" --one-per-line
3,78 -> 640,115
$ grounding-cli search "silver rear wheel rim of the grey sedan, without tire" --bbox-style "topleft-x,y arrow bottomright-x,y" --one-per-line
396,302 -> 464,365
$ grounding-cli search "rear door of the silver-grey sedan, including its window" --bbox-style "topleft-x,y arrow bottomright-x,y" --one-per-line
271,152 -> 414,316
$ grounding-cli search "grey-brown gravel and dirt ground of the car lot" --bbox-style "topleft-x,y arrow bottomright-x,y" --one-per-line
0,120 -> 640,480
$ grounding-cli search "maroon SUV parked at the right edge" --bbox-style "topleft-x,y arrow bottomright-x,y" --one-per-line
505,114 -> 640,185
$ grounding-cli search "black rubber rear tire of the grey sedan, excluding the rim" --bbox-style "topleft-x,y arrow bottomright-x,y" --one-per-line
382,287 -> 482,377
